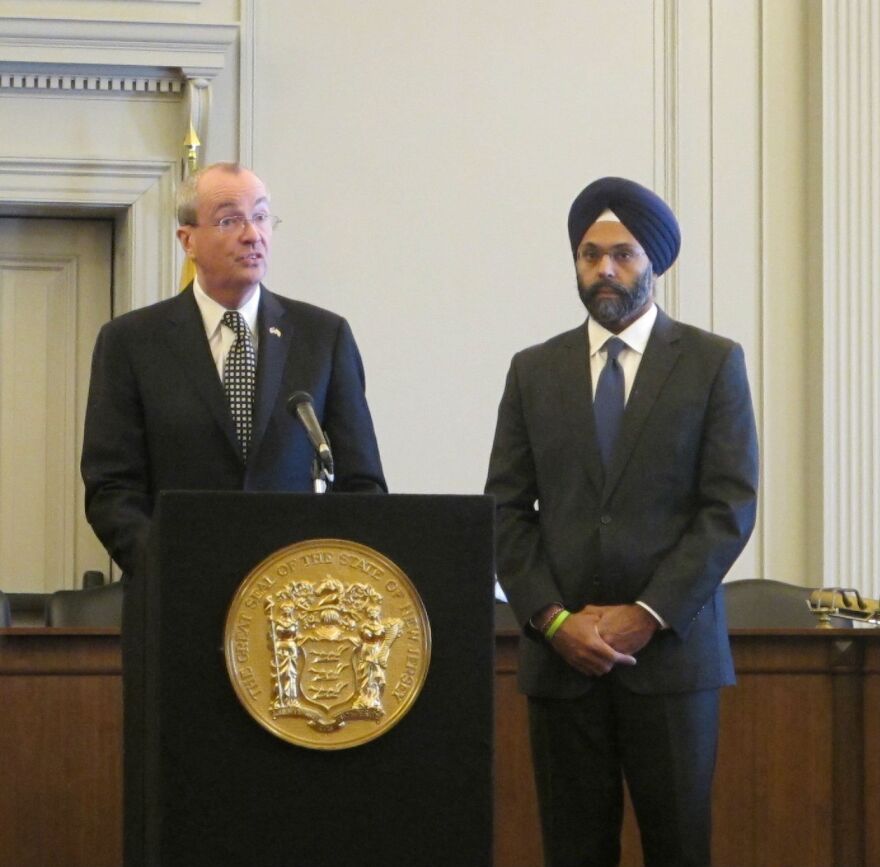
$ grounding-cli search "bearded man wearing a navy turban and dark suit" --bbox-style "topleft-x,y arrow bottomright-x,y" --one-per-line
486,178 -> 758,867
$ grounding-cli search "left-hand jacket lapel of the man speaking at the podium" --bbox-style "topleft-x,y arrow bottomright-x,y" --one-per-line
168,286 -> 240,453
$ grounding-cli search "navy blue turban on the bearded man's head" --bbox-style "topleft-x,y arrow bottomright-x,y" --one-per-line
568,178 -> 681,277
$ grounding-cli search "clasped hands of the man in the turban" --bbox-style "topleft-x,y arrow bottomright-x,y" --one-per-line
550,605 -> 659,676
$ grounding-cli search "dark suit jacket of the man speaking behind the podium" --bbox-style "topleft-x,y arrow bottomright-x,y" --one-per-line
82,287 -> 385,573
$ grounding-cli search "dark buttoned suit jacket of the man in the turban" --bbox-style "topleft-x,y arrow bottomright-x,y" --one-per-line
486,310 -> 758,697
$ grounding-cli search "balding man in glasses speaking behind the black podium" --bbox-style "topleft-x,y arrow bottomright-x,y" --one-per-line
82,163 -> 386,574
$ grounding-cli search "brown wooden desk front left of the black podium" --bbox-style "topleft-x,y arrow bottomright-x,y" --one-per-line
0,629 -> 122,867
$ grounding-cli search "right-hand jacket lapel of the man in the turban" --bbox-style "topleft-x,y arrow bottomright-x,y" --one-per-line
603,308 -> 681,501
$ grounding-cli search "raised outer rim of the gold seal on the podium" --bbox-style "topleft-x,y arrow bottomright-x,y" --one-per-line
223,537 -> 432,751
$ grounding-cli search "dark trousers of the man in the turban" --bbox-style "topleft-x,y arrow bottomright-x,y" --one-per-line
529,672 -> 718,867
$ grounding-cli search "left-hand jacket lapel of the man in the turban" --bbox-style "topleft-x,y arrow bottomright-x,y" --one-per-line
552,325 -> 603,491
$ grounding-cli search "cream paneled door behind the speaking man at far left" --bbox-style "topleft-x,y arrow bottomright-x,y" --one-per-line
0,218 -> 113,592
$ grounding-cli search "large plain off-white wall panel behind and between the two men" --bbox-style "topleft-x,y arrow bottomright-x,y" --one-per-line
253,0 -> 654,493
